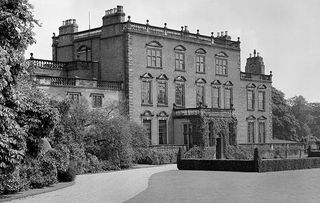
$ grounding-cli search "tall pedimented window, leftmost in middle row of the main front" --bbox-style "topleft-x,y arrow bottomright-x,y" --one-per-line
140,73 -> 153,105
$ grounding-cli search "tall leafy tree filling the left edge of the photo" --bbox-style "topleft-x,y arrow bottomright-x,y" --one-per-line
0,0 -> 56,173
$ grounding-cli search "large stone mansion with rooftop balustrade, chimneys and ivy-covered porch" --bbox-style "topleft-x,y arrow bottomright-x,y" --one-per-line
30,6 -> 272,154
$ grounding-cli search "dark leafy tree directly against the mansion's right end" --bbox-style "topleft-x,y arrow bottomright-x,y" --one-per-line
272,87 -> 300,141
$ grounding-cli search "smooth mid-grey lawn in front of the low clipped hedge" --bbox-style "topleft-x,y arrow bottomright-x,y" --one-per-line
128,169 -> 320,203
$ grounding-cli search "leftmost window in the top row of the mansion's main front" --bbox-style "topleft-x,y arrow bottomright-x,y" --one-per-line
146,41 -> 162,68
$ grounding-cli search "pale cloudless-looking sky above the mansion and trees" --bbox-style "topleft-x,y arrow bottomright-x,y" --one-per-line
26,0 -> 320,102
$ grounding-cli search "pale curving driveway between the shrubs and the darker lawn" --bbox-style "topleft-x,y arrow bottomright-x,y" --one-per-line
9,164 -> 177,203
